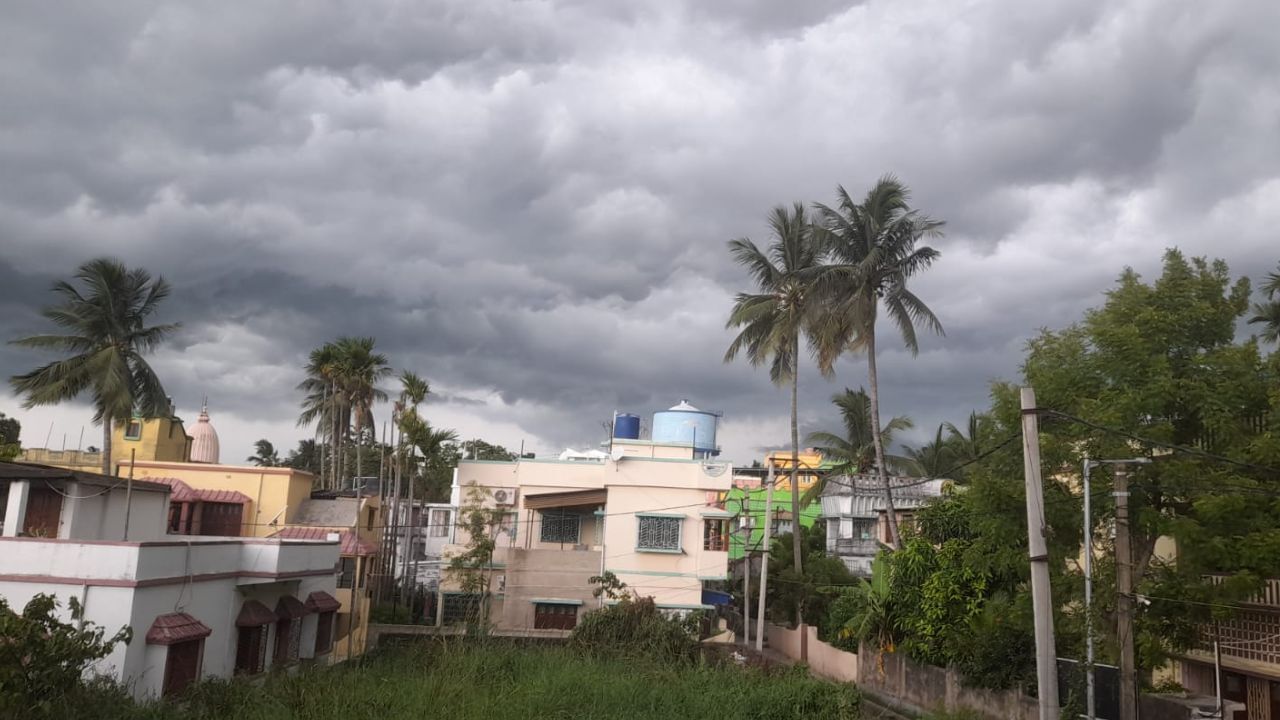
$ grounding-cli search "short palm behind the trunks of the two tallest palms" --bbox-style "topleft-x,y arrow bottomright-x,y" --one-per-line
801,387 -> 915,505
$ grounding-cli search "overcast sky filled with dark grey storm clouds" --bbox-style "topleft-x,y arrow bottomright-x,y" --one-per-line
0,0 -> 1280,462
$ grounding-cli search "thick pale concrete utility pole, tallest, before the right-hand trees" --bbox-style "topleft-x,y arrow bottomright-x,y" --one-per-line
1021,387 -> 1059,720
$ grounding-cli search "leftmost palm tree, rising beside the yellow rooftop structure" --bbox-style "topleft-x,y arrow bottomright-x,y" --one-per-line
9,258 -> 179,475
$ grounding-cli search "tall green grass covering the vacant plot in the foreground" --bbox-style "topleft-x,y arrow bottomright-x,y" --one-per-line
59,641 -> 859,720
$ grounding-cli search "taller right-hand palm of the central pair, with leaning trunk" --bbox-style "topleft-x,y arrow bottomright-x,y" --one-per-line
817,176 -> 942,547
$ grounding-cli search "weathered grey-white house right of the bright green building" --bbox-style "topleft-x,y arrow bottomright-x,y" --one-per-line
822,475 -> 945,575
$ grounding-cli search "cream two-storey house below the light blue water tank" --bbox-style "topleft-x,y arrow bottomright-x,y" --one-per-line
436,438 -> 732,630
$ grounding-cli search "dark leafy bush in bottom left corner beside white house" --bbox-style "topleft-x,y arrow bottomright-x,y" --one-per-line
0,594 -> 132,717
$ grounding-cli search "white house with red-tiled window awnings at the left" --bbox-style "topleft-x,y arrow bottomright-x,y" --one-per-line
0,462 -> 338,698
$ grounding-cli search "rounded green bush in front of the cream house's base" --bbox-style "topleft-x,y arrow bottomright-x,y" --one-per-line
571,597 -> 698,664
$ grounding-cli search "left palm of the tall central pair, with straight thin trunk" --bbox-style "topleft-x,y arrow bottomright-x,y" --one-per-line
724,202 -> 822,573
